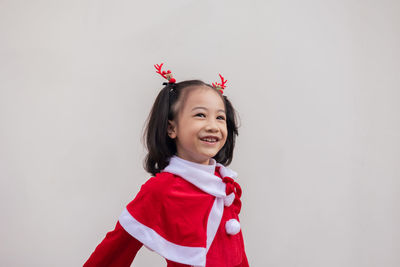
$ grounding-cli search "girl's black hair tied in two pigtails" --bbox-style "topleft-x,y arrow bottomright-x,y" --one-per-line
143,80 -> 238,175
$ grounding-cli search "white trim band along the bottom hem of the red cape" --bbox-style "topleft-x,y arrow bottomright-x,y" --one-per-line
119,208 -> 208,266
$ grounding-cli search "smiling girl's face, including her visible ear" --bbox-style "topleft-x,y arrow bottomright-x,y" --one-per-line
168,86 -> 227,164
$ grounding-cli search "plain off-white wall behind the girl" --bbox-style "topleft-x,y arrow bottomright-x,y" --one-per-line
0,0 -> 400,267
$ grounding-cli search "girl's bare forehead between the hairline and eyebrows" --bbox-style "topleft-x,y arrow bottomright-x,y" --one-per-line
183,86 -> 225,110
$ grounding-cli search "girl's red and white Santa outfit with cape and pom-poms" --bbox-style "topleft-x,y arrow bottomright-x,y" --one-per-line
84,156 -> 249,267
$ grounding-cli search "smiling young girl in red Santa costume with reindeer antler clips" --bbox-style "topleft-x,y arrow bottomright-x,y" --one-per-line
84,64 -> 249,267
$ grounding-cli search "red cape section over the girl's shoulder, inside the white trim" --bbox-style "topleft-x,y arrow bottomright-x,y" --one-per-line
127,172 -> 215,247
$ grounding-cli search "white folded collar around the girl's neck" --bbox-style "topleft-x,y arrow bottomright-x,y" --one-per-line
162,156 -> 237,197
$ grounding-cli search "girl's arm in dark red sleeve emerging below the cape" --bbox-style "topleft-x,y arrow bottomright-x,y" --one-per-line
83,222 -> 143,267
